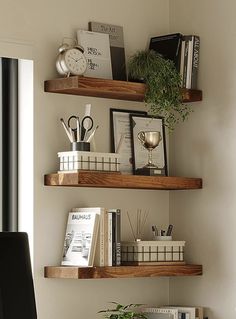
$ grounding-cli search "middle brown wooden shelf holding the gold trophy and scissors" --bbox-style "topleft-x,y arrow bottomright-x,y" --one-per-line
44,170 -> 202,190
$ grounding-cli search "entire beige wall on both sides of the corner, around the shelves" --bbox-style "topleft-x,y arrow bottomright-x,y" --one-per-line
0,0 -> 230,319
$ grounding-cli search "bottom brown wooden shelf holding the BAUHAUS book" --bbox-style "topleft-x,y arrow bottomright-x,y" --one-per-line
44,264 -> 202,279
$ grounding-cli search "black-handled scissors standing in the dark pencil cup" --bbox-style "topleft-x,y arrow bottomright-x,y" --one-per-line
68,115 -> 93,142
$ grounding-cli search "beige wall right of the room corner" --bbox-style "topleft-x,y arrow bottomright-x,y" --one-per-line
170,0 -> 236,319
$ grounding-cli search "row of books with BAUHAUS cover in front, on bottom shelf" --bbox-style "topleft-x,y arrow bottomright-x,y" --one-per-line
61,207 -> 121,267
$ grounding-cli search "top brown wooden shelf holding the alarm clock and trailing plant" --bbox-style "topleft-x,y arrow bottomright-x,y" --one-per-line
44,76 -> 202,103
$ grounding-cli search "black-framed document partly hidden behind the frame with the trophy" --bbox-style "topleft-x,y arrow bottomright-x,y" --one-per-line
110,108 -> 147,174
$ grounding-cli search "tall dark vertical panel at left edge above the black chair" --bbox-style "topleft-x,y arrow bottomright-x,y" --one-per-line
1,58 -> 18,231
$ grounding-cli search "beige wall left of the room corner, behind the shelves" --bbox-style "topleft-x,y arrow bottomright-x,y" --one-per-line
0,0 -> 173,319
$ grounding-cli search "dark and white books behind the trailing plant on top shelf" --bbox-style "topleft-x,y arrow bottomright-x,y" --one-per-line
149,33 -> 200,89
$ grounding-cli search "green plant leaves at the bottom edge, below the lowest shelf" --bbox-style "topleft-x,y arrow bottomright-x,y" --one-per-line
99,302 -> 148,319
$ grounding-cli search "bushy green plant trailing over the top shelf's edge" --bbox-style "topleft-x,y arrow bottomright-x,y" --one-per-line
128,50 -> 191,130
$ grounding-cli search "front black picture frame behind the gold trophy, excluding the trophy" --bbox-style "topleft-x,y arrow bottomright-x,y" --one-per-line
130,114 -> 168,176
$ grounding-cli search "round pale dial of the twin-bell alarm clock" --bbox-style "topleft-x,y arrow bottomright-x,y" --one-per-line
65,49 -> 87,75
